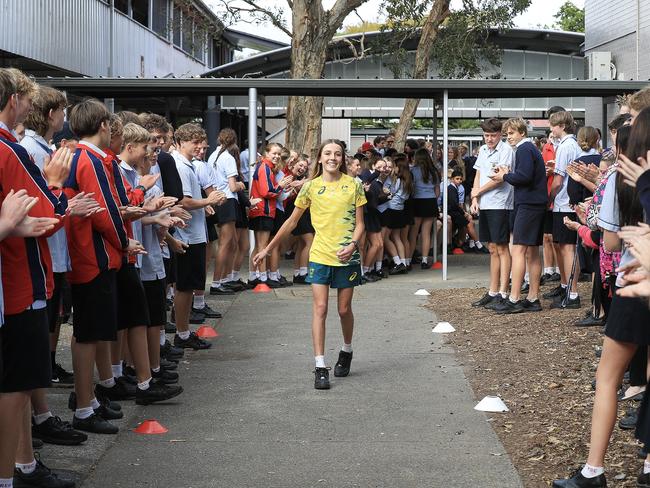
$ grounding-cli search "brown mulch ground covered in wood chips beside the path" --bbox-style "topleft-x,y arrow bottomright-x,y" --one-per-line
427,283 -> 643,487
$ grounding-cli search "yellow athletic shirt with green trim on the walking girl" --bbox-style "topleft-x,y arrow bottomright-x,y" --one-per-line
295,174 -> 366,266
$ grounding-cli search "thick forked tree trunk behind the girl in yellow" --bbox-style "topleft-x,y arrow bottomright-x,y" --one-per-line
285,0 -> 367,157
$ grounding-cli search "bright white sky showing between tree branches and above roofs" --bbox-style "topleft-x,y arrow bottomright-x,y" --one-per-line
205,0 -> 584,42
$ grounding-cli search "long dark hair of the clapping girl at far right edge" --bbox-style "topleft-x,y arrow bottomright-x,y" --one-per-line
616,108 -> 650,226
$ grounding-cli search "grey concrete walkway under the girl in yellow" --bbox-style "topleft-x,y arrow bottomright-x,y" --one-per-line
43,256 -> 521,488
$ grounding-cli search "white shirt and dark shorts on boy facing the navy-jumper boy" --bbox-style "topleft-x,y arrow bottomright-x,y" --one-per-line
474,141 -> 515,244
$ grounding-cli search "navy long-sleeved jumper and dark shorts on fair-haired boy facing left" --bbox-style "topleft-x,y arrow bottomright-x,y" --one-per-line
503,139 -> 548,246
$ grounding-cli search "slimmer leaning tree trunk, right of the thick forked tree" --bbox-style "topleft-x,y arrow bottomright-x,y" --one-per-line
395,0 -> 450,150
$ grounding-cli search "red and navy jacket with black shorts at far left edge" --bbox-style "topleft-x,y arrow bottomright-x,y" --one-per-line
0,123 -> 67,393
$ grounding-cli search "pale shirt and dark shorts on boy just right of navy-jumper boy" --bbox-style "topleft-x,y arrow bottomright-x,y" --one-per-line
553,134 -> 582,244
